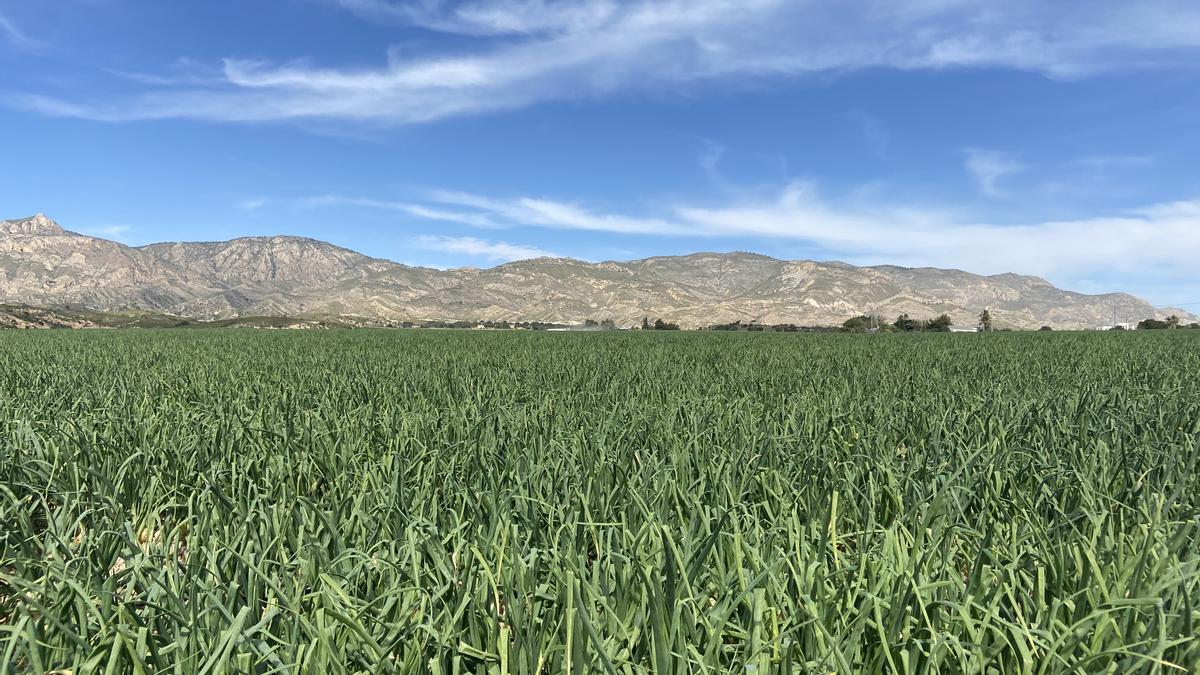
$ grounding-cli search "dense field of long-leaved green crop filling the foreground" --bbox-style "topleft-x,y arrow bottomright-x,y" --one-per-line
0,330 -> 1200,675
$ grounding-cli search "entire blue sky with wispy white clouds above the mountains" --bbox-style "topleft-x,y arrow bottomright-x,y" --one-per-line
0,0 -> 1200,305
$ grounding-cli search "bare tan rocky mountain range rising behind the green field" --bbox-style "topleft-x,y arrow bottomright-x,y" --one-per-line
0,214 -> 1180,328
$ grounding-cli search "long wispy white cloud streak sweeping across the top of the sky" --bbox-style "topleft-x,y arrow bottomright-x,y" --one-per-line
10,0 -> 1200,124
